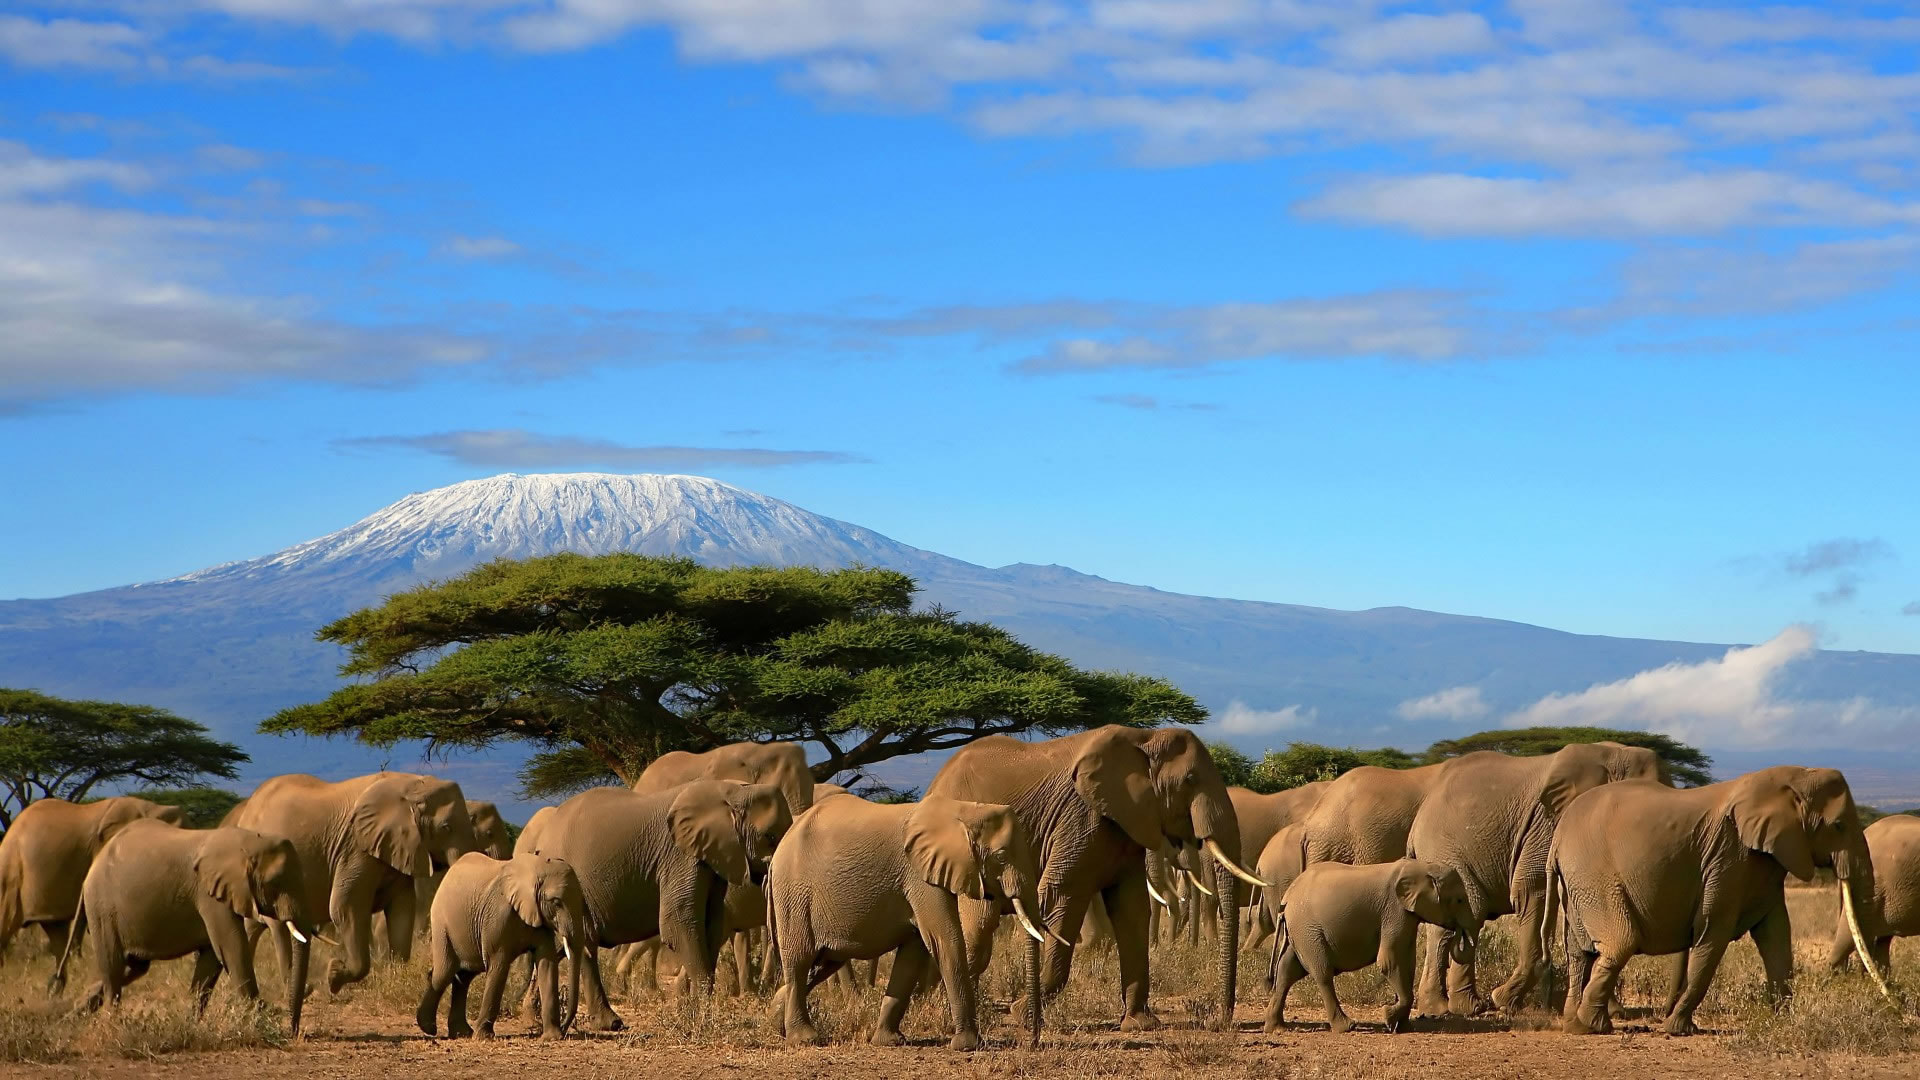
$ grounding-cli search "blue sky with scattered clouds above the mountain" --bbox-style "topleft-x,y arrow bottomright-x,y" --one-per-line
0,0 -> 1920,651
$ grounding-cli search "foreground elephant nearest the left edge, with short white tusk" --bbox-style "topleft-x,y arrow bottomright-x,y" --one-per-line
52,819 -> 319,1036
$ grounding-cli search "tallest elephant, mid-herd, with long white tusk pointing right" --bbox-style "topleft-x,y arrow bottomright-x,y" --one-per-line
927,726 -> 1258,1032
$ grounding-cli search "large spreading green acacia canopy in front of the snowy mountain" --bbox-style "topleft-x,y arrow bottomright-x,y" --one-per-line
261,553 -> 1206,798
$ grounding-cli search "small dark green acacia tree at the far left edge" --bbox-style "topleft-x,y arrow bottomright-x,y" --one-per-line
0,688 -> 248,828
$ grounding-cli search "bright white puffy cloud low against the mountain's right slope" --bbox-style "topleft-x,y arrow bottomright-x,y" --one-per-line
1505,626 -> 1920,748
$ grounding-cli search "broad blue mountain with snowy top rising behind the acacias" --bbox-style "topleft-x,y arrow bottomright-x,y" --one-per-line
0,473 -> 1920,794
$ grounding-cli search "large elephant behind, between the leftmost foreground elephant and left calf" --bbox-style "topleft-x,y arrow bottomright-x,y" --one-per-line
223,773 -> 476,994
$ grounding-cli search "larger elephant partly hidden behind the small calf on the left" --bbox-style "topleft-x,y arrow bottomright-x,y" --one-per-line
515,780 -> 793,1030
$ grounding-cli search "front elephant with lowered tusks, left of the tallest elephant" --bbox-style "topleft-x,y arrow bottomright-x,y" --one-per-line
768,796 -> 1043,1049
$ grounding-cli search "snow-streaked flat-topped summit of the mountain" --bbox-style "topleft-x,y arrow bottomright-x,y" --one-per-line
159,473 -> 960,584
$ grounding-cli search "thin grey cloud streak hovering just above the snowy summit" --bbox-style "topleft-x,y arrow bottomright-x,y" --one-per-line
334,429 -> 868,469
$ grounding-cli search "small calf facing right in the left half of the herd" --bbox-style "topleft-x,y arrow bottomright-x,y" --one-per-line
415,851 -> 593,1040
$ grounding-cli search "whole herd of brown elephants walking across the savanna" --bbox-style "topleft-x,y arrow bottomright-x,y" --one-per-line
0,726 -> 1920,1049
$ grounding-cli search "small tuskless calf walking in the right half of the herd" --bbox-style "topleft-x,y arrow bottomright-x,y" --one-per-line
1267,859 -> 1480,1032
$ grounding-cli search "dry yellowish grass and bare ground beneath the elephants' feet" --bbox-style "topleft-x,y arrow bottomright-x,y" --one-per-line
0,890 -> 1920,1080
